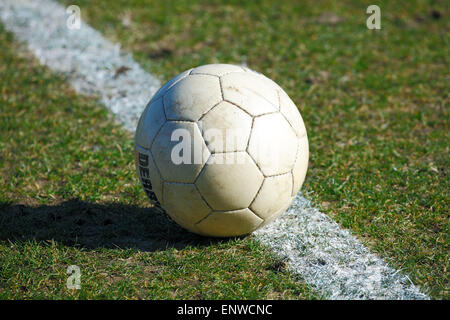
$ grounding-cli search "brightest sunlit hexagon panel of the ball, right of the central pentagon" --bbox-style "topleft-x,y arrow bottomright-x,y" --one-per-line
248,113 -> 298,176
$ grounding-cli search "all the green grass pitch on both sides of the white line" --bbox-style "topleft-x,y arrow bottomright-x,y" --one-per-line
0,0 -> 450,299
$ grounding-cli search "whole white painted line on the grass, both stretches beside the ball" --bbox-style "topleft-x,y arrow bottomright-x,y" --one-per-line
0,0 -> 428,299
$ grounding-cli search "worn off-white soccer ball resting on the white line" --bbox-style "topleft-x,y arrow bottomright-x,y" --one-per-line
135,64 -> 308,237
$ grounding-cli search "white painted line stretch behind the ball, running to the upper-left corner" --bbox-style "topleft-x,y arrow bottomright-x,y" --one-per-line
0,0 -> 161,131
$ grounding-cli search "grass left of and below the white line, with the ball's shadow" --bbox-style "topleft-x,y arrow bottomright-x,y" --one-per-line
0,25 -> 317,299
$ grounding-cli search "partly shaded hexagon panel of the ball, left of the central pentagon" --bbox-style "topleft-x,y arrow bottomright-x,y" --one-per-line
151,121 -> 210,183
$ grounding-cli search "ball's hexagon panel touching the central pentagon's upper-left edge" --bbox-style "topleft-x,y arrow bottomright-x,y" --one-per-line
164,74 -> 222,121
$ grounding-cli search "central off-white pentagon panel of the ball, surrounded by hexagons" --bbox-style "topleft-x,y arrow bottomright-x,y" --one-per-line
199,101 -> 252,152
